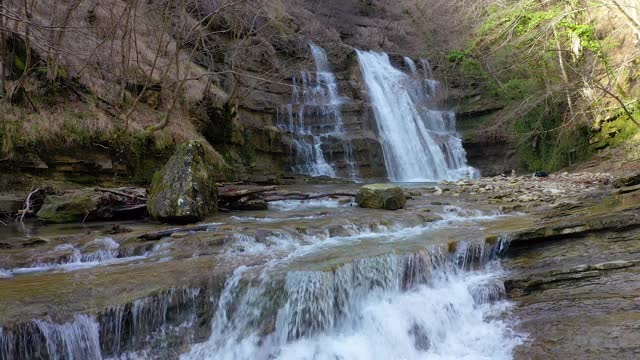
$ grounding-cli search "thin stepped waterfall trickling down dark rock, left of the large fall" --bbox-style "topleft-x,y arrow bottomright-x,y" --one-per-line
278,43 -> 358,179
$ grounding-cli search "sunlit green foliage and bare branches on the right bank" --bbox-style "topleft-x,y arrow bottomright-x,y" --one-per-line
446,0 -> 640,170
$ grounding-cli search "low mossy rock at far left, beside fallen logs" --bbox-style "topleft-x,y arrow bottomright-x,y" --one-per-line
36,191 -> 97,223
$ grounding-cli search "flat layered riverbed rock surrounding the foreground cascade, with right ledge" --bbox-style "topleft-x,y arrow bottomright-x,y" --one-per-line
0,173 -> 640,359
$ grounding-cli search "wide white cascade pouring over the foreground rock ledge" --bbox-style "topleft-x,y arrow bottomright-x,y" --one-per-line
181,242 -> 521,360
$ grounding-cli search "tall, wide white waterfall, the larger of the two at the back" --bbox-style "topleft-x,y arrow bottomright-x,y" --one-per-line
357,50 -> 478,182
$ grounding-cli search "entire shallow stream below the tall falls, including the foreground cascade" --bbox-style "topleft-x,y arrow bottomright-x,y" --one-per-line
0,184 -> 526,359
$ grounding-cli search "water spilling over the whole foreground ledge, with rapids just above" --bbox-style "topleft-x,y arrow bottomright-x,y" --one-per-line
0,206 -> 521,360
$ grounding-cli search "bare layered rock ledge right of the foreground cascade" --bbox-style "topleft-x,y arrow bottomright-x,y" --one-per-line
503,186 -> 640,359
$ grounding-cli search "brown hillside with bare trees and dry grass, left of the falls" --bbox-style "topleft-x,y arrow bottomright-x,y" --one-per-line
0,0 -> 306,182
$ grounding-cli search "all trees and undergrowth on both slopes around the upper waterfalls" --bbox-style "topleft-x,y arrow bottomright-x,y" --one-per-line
0,0 -> 640,182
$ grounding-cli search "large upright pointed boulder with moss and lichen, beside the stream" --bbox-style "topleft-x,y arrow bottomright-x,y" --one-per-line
147,141 -> 218,224
